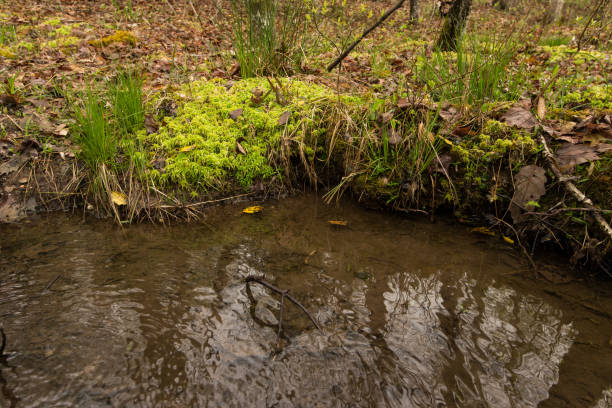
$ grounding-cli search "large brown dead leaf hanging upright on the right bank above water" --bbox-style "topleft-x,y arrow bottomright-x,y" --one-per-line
510,164 -> 546,223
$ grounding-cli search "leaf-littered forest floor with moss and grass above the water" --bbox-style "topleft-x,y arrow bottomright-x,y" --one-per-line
0,0 -> 612,280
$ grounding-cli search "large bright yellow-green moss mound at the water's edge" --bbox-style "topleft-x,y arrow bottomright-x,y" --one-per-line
139,78 -> 360,191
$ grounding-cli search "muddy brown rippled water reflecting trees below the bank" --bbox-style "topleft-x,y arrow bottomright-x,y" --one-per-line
0,196 -> 612,407
